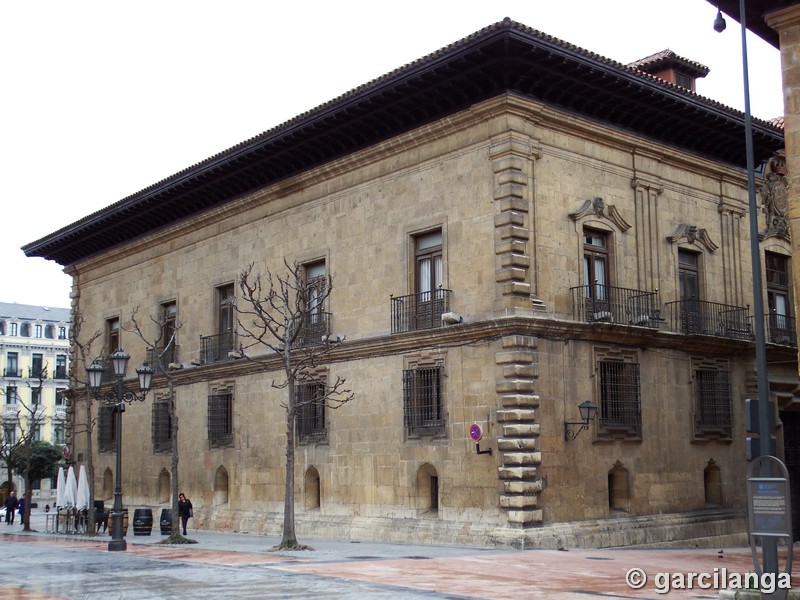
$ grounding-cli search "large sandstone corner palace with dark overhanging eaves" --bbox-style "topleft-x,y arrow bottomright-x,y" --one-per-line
25,20 -> 800,546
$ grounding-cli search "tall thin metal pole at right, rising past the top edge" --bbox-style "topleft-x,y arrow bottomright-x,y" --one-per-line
739,0 -> 778,574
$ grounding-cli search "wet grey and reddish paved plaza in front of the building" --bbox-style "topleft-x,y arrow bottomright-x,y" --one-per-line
0,514 -> 800,600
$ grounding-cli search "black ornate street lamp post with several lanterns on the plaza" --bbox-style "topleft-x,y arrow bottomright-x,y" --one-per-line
86,349 -> 154,552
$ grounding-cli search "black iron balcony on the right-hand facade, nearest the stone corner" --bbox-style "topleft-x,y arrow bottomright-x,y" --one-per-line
570,283 -> 663,329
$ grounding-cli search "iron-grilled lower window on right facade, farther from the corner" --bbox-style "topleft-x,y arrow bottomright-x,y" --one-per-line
694,369 -> 732,438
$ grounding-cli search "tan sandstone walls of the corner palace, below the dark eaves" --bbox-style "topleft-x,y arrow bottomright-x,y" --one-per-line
57,95 -> 798,546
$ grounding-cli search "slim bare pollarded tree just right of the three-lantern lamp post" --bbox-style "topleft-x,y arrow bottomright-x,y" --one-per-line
130,309 -> 194,544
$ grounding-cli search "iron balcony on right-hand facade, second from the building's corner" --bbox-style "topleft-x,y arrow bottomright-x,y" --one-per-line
664,300 -> 753,340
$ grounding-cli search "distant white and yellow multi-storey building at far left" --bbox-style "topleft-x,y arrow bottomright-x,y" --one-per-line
0,302 -> 70,502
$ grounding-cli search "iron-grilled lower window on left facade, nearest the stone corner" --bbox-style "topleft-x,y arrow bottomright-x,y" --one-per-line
403,366 -> 444,434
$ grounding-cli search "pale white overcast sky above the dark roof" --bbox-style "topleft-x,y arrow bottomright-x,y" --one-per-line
0,0 -> 783,308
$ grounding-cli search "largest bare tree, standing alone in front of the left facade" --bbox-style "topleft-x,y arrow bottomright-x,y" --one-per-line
236,261 -> 354,549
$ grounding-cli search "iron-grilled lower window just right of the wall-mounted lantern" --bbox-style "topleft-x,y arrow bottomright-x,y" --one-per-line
598,361 -> 642,437
